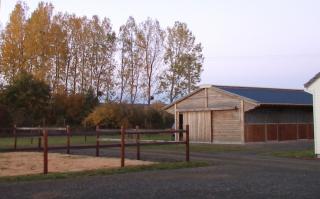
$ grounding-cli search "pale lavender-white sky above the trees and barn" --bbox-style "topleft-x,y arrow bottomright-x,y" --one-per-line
0,0 -> 320,88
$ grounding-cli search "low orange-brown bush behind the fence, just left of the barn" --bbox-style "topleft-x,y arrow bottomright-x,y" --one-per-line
83,103 -> 173,128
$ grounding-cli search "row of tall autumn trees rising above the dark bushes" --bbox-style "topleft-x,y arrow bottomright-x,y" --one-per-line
0,2 -> 204,104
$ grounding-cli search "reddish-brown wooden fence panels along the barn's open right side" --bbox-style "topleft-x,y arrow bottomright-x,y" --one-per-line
245,123 -> 313,142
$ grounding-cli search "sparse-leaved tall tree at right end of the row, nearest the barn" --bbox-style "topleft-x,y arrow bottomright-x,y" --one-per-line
160,22 -> 203,102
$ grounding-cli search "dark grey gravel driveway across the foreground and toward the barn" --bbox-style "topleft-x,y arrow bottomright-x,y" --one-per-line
0,143 -> 320,199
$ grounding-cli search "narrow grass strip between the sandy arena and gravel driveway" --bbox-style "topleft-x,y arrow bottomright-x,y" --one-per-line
0,162 -> 209,182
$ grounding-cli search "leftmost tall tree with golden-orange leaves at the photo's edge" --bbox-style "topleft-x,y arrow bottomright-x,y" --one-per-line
0,2 -> 27,82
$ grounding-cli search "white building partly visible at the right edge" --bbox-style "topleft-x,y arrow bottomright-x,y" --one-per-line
304,72 -> 320,158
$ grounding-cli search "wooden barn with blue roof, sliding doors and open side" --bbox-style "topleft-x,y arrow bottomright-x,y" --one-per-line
164,85 -> 313,144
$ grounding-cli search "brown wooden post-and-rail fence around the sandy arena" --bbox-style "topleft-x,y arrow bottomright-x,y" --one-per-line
2,125 -> 190,174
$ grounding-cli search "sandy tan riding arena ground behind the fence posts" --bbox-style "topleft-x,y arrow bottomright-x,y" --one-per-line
0,152 -> 153,177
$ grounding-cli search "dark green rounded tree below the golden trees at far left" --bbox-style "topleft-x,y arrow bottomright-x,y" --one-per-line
0,72 -> 51,125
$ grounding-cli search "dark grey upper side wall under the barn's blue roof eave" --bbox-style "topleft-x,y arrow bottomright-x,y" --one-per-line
245,107 -> 313,124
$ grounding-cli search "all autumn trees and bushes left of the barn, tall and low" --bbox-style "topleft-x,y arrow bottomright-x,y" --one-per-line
0,1 -> 203,128
